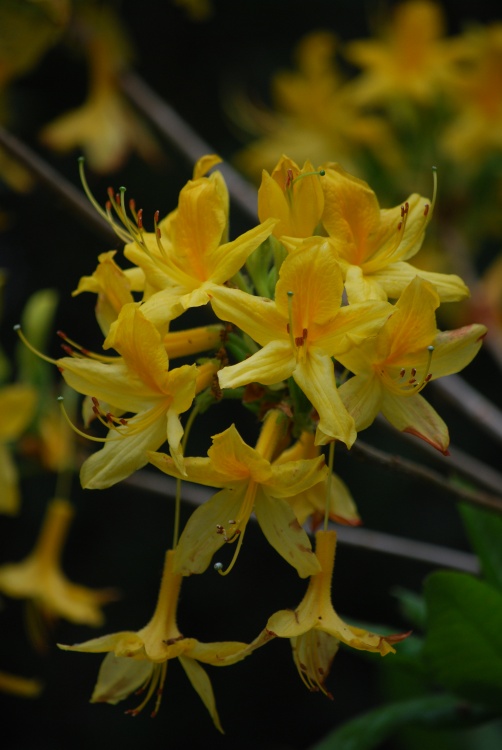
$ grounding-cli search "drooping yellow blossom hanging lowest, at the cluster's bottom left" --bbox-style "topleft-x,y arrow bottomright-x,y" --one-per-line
59,550 -> 246,732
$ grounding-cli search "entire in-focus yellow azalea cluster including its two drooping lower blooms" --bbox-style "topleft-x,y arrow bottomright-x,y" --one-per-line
14,150 -> 486,729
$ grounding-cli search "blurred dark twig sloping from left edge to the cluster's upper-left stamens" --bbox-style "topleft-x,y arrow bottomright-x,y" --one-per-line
0,127 -> 117,246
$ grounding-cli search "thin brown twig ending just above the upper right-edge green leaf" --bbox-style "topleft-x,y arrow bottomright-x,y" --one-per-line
341,440 -> 502,514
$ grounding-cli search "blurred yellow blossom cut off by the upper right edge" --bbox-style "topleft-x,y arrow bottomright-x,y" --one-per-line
441,23 -> 502,167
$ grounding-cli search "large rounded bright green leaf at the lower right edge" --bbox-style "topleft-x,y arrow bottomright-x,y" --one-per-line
423,572 -> 502,710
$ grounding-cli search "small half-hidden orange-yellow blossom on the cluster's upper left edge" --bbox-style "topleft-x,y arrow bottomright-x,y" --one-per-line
73,250 -> 144,336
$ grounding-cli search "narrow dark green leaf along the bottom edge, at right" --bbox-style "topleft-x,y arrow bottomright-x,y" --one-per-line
310,695 -> 485,750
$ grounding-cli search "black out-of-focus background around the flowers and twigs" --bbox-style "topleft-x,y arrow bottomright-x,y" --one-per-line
0,0 -> 501,750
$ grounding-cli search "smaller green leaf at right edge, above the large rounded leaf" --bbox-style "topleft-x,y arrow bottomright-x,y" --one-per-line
459,503 -> 502,591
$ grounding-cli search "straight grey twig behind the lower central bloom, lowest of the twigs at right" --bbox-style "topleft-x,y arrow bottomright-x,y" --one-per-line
124,469 -> 479,574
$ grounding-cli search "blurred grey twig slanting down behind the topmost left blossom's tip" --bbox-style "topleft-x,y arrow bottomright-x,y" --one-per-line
120,71 -> 257,221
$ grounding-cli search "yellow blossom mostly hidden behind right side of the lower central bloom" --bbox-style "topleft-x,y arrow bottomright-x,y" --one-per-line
274,432 -> 361,529
